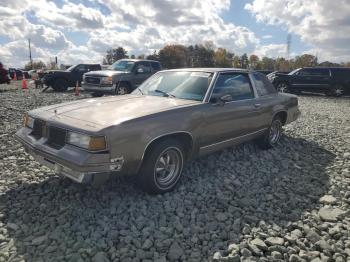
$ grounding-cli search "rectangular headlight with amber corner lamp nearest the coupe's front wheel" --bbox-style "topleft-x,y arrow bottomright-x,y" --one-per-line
67,132 -> 106,151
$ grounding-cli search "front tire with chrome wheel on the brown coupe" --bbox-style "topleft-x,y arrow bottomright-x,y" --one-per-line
137,139 -> 185,194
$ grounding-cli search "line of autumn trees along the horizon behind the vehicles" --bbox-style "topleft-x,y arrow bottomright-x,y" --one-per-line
103,42 -> 350,71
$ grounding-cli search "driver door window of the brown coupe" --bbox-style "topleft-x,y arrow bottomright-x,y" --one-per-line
212,73 -> 254,101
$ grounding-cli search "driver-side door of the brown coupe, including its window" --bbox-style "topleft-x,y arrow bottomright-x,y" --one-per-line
200,72 -> 264,154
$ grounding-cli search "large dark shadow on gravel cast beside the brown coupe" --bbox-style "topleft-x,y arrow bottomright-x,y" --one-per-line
0,136 -> 334,261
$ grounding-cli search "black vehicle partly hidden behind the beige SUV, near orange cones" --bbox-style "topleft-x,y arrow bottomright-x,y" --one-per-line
43,64 -> 101,91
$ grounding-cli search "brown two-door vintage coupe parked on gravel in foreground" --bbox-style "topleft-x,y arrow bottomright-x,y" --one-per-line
16,68 -> 300,193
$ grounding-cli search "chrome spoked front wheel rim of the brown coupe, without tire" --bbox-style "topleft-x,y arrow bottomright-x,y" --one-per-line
154,147 -> 183,188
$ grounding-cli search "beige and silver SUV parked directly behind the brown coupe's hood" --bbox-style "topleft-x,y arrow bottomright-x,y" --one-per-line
82,59 -> 162,97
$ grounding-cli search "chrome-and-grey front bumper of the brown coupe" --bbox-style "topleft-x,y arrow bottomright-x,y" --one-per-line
16,127 -> 115,183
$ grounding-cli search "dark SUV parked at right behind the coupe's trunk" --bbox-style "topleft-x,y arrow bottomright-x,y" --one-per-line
267,67 -> 350,96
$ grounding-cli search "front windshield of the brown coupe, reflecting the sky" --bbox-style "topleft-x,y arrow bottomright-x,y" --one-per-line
134,71 -> 213,101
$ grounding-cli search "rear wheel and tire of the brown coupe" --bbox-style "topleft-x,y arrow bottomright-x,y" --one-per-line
258,117 -> 282,149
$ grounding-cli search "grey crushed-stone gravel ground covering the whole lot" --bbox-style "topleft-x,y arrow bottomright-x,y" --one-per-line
0,83 -> 350,262
